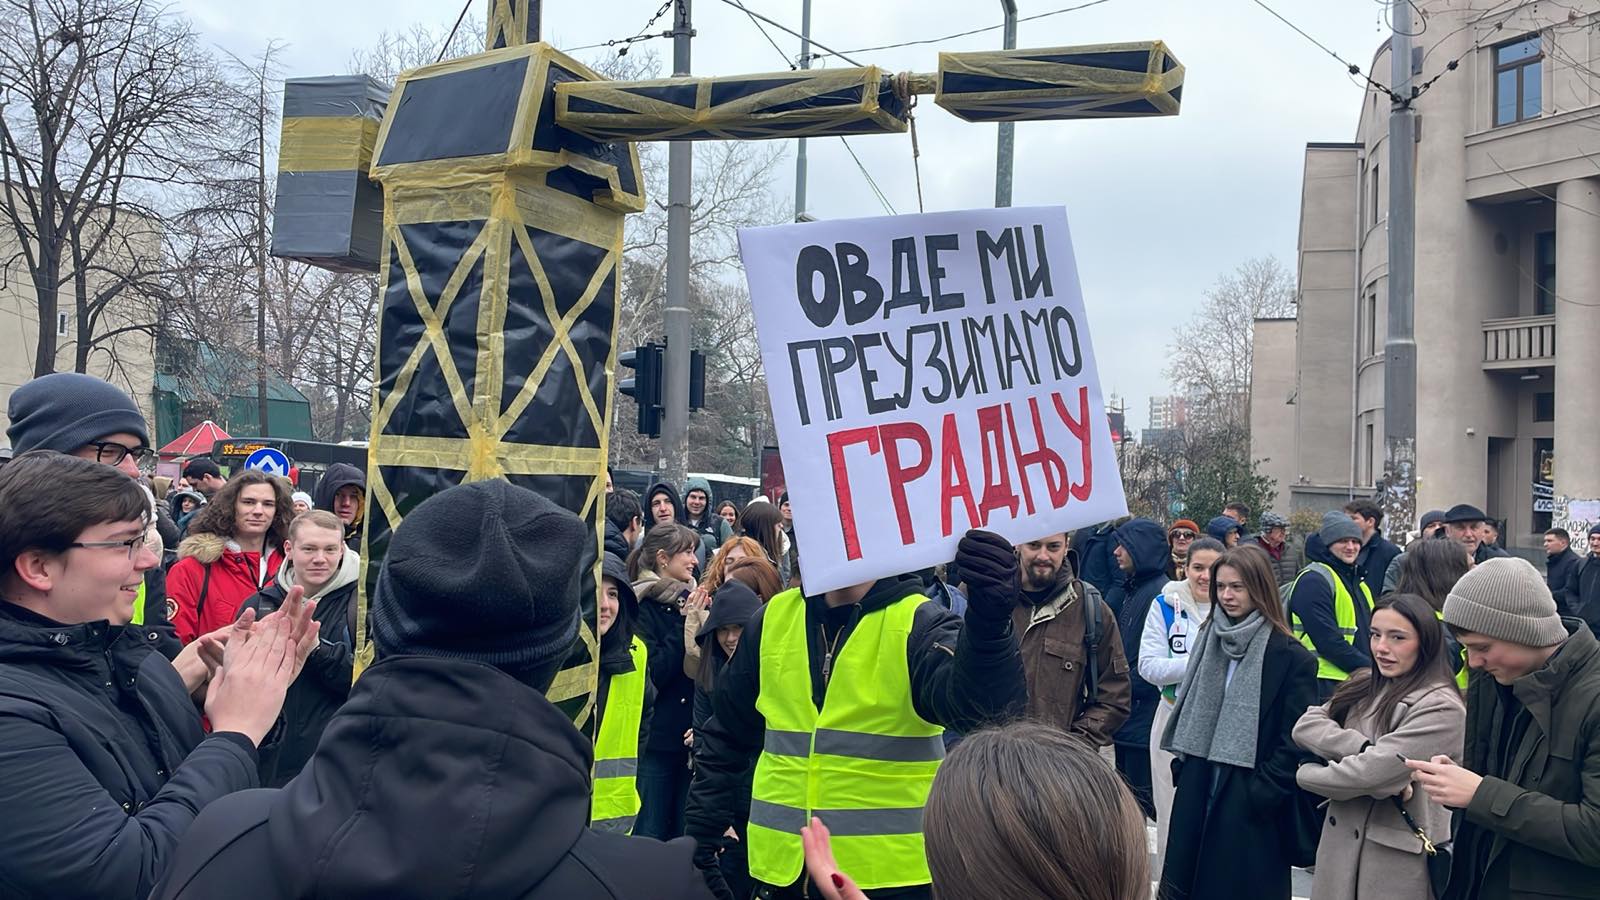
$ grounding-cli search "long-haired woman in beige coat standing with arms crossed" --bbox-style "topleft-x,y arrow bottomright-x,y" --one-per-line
1294,595 -> 1467,900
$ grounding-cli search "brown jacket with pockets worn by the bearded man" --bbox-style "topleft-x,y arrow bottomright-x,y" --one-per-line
1011,564 -> 1133,746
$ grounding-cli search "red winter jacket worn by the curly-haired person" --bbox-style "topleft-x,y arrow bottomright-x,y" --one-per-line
166,535 -> 283,644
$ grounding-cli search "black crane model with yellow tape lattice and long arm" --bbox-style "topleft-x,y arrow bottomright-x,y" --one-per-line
272,0 -> 1184,717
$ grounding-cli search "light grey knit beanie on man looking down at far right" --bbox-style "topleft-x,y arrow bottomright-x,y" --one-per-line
1445,557 -> 1566,647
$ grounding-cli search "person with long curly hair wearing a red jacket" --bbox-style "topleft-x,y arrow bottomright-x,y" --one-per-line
166,469 -> 294,644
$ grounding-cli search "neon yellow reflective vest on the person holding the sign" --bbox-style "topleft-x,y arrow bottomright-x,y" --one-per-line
747,589 -> 944,890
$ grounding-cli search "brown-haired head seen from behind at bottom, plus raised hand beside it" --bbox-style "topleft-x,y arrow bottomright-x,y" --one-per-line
802,722 -> 1150,900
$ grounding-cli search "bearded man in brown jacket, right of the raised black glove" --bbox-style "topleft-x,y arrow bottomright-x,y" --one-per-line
1011,533 -> 1133,746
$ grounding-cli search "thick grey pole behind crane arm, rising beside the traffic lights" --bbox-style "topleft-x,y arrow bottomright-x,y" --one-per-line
656,0 -> 694,484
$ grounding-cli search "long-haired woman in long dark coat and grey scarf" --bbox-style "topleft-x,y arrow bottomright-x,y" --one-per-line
1160,546 -> 1317,900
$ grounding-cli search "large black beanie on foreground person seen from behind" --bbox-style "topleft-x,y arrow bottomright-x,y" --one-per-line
371,479 -> 594,679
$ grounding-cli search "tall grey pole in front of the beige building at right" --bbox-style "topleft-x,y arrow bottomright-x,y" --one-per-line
1382,0 -> 1416,532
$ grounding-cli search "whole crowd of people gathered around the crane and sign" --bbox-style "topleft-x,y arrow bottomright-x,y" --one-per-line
0,373 -> 1600,900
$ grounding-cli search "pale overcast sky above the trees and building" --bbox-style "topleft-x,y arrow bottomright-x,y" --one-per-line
176,0 -> 1387,429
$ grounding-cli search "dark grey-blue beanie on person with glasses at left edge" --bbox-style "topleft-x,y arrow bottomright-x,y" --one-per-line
6,372 -> 150,455
